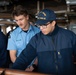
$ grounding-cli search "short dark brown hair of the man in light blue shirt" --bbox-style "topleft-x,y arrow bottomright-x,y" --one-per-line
12,5 -> 28,17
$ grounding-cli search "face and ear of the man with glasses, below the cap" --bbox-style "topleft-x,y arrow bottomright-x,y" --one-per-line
36,21 -> 55,35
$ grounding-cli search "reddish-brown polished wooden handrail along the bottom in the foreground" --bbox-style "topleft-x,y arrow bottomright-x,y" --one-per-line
0,68 -> 48,75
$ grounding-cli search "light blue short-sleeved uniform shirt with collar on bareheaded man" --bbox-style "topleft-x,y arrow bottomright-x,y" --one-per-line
7,25 -> 40,57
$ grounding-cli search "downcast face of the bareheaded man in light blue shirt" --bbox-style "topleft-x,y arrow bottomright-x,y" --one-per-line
14,15 -> 28,30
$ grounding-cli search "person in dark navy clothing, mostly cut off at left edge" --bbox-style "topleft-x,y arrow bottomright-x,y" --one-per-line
0,28 -> 8,68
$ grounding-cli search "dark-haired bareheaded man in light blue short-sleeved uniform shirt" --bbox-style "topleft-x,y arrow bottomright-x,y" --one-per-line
7,5 -> 40,71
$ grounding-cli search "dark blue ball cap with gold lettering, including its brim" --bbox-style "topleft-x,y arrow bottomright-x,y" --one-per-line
35,9 -> 56,25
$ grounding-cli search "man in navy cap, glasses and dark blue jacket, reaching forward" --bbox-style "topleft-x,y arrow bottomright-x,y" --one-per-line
12,9 -> 76,75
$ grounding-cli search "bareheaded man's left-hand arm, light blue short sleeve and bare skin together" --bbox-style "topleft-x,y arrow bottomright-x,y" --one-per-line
7,32 -> 17,63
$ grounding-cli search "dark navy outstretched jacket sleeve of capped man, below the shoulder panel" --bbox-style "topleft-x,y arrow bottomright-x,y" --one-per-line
12,44 -> 36,70
